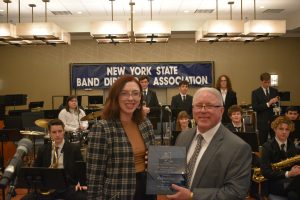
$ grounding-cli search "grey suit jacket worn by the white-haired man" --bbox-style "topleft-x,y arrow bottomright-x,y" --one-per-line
176,125 -> 252,200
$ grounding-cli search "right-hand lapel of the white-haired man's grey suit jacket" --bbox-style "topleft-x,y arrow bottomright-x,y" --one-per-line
192,125 -> 224,188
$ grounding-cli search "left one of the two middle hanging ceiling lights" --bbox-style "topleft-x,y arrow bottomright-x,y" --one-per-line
90,0 -> 130,44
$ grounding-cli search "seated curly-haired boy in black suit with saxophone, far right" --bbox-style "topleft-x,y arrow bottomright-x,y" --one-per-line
261,116 -> 300,200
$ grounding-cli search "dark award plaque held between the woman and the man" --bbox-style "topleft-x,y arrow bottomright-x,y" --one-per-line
146,146 -> 186,195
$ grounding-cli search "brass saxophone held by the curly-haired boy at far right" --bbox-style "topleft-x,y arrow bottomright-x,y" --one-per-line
252,155 -> 300,183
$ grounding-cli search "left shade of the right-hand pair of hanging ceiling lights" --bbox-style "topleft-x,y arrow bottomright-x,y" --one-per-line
196,0 -> 244,42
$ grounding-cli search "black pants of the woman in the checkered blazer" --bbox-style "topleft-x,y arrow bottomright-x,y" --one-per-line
134,172 -> 156,200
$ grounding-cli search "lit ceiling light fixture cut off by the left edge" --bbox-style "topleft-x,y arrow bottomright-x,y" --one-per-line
0,0 -> 16,45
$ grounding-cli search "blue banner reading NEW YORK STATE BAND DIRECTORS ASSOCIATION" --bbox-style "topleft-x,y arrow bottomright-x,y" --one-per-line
71,62 -> 213,89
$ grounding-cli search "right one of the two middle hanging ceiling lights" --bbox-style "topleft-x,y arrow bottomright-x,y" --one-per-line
134,0 -> 171,44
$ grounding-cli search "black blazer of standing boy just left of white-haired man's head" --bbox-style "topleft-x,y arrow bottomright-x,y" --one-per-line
171,94 -> 193,119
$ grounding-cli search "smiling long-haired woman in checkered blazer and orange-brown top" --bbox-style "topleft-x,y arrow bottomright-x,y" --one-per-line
87,75 -> 155,200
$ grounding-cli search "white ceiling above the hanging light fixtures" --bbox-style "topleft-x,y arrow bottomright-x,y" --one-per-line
0,0 -> 300,32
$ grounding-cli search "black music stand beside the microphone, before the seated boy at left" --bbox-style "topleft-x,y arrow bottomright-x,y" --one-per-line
16,167 -> 67,199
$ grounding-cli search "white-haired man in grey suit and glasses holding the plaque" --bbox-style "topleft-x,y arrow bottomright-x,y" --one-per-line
167,88 -> 252,200
